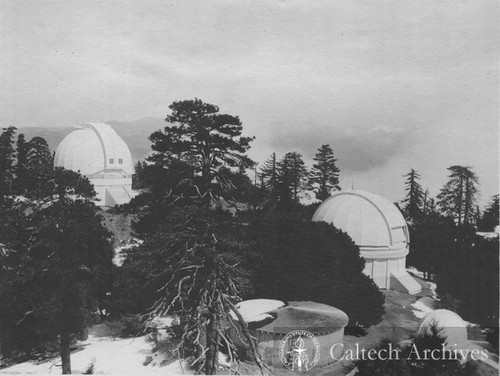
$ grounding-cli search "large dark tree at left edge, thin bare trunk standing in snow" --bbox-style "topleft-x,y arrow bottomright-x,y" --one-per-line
0,169 -> 112,374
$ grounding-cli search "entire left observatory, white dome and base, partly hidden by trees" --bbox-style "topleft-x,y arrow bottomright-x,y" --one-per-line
54,123 -> 134,207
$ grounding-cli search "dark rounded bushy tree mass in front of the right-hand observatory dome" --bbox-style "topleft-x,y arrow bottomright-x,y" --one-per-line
250,212 -> 384,326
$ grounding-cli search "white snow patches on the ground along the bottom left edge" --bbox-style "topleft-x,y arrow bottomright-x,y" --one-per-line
0,336 -> 192,375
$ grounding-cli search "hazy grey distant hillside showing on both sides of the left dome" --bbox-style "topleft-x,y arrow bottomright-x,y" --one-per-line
18,117 -> 166,161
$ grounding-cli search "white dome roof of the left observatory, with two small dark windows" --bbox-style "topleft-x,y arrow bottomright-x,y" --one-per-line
54,123 -> 134,176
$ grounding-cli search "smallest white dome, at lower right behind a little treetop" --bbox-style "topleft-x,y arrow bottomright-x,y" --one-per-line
417,309 -> 467,348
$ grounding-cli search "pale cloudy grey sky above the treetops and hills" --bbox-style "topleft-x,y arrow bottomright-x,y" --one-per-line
0,0 -> 500,206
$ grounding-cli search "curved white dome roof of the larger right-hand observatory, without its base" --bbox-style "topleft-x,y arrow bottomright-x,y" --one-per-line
312,190 -> 409,250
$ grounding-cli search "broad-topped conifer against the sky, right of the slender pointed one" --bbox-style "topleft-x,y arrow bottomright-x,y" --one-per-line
437,165 -> 478,225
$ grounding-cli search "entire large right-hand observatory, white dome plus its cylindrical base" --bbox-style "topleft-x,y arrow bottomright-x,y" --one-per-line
312,190 -> 421,294
